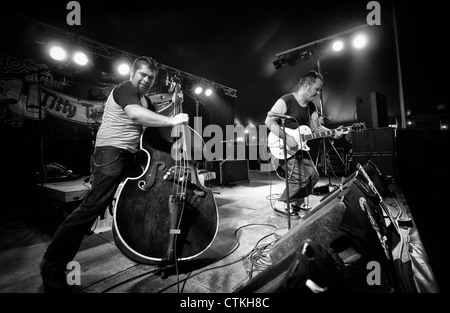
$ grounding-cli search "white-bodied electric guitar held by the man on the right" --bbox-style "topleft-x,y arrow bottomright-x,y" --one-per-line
267,123 -> 366,159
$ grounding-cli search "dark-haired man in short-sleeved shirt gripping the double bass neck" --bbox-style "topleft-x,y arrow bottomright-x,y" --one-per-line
41,56 -> 189,292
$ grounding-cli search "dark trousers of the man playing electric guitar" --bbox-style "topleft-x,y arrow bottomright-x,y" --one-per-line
279,156 -> 320,203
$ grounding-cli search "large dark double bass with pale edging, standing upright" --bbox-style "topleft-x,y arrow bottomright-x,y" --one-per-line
112,80 -> 219,267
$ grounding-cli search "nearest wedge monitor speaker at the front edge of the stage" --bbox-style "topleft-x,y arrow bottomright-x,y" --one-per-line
236,193 -> 351,293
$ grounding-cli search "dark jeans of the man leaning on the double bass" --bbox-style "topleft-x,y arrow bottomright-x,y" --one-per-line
42,146 -> 135,271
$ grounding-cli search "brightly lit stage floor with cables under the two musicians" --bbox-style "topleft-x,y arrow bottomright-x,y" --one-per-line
0,170 -> 442,293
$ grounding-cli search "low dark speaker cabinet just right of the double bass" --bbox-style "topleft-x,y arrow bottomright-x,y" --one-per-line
206,160 -> 249,185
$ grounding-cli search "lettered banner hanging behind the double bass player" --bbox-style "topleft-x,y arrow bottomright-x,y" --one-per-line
0,53 -> 110,140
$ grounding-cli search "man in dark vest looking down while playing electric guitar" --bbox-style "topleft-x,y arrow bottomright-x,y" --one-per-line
265,71 -> 343,219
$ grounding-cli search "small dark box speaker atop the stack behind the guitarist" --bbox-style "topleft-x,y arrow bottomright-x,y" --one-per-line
356,92 -> 388,128
